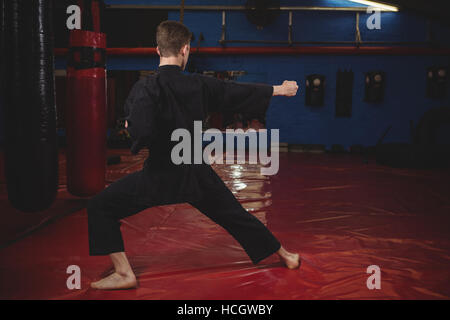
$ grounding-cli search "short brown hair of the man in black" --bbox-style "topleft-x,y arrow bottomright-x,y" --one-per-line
156,20 -> 192,57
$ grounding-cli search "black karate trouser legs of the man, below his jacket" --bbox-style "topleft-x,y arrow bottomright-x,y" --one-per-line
87,166 -> 281,264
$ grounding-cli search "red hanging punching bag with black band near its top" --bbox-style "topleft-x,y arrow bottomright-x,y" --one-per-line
66,1 -> 106,197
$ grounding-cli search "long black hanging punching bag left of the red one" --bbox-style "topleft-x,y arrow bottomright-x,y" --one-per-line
4,0 -> 58,212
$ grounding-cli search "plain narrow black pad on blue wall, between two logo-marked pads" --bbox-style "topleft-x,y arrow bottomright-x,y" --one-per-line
336,70 -> 353,117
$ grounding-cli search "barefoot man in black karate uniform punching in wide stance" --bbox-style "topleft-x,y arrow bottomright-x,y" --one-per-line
87,21 -> 300,289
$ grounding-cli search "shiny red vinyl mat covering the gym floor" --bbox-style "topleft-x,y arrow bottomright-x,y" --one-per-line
0,150 -> 450,299
